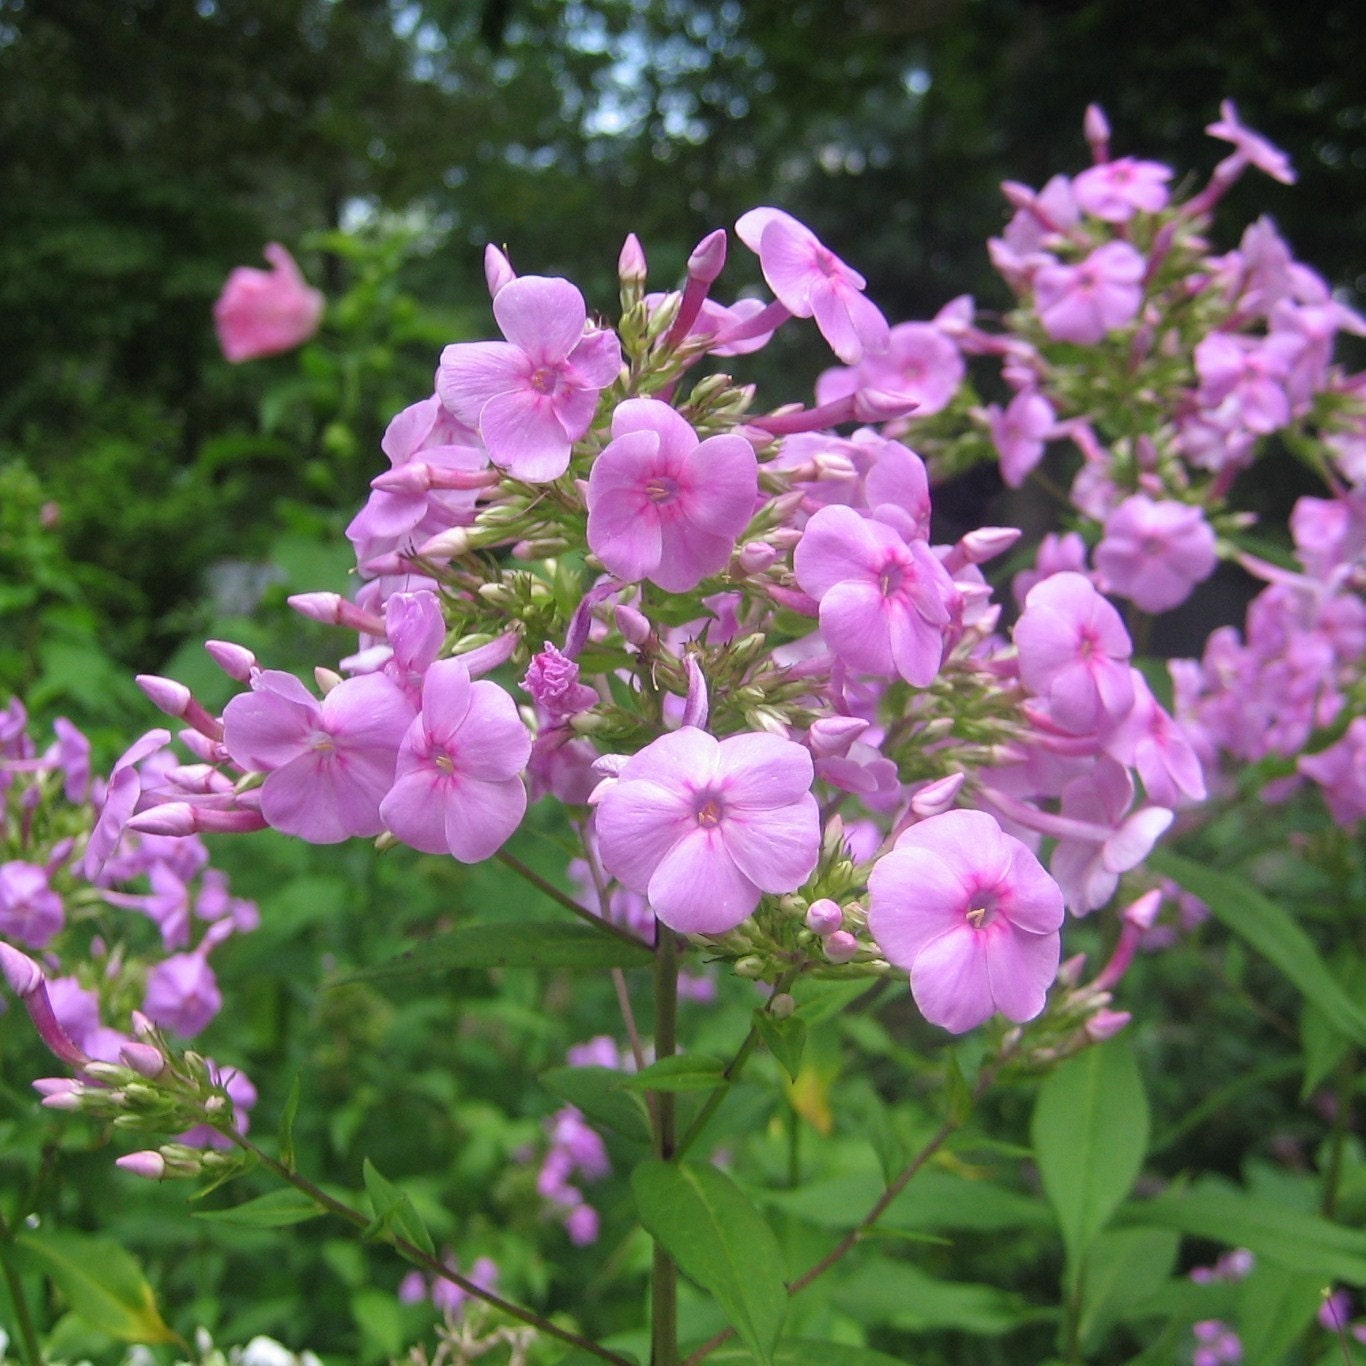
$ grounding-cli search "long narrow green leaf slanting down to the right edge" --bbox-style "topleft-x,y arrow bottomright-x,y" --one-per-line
1149,850 -> 1366,1048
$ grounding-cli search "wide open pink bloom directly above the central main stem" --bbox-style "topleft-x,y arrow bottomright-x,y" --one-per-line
596,727 -> 821,934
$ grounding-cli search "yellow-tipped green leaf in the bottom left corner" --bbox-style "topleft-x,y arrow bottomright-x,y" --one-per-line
15,1232 -> 180,1344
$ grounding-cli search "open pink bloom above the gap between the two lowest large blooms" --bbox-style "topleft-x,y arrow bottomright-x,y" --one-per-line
794,507 -> 962,687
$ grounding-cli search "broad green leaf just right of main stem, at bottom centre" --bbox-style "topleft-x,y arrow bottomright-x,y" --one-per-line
631,1158 -> 787,1366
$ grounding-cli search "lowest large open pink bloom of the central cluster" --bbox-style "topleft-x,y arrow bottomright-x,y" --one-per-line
867,811 -> 1063,1034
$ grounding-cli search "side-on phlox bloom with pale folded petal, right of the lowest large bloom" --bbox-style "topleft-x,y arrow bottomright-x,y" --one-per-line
1040,754 -> 1172,915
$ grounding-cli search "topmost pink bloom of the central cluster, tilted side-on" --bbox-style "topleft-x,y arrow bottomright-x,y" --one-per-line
735,208 -> 888,365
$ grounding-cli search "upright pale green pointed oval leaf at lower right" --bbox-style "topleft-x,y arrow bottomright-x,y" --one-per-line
1030,1034 -> 1149,1276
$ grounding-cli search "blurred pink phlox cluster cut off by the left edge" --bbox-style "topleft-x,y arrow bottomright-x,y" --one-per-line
0,701 -> 258,1147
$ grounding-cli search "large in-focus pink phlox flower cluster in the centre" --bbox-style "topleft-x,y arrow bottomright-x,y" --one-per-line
79,199 -> 1203,1043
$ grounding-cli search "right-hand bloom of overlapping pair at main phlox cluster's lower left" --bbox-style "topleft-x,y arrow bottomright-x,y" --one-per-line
380,655 -> 531,863
